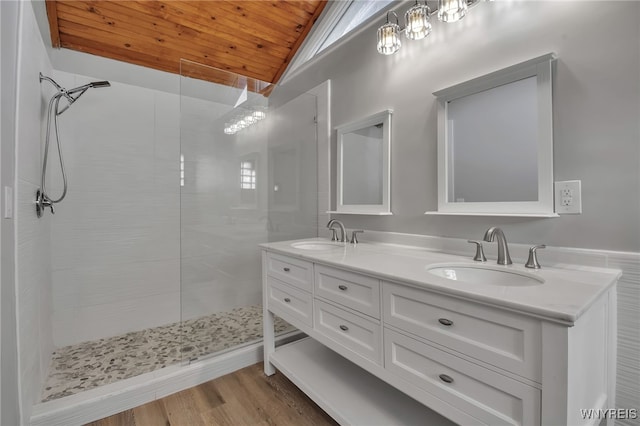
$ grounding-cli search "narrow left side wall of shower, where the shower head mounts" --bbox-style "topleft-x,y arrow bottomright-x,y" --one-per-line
14,2 -> 55,419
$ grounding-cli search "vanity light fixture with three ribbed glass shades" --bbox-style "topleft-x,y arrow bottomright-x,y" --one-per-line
377,0 -> 480,55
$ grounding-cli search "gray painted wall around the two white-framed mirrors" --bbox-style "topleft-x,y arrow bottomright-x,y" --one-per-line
285,1 -> 640,251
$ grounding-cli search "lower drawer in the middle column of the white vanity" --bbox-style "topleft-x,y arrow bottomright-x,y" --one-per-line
313,299 -> 382,365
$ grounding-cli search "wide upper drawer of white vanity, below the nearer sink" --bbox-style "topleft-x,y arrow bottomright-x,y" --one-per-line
382,282 -> 542,383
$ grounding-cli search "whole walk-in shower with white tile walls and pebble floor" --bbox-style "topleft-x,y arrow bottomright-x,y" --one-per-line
17,9 -> 317,414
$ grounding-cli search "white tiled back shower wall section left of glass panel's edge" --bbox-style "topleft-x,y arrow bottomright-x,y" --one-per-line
51,72 -> 188,345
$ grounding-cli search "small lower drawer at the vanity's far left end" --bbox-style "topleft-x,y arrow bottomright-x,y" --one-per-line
267,277 -> 313,327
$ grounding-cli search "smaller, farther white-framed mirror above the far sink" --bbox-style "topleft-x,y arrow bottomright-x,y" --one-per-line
333,110 -> 393,215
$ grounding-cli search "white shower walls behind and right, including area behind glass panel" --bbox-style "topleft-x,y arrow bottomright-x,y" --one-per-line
44,65 -> 316,347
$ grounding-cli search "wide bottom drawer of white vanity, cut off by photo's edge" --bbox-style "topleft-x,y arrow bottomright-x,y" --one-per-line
384,328 -> 541,426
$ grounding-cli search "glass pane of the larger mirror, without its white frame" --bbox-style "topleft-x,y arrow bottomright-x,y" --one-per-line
447,77 -> 538,203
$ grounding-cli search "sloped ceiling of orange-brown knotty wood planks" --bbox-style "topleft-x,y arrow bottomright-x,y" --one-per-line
46,0 -> 327,83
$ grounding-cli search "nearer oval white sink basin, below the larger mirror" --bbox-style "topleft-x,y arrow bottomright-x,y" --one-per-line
427,265 -> 544,286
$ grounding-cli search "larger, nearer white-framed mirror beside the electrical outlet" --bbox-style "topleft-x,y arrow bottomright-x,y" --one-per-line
427,54 -> 556,217
